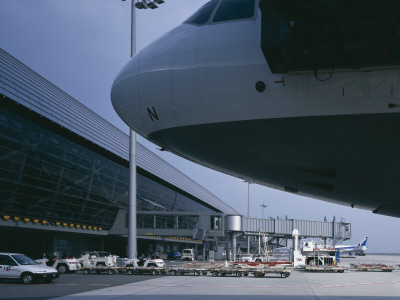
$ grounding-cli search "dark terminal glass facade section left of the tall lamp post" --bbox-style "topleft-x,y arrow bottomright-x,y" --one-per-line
0,102 -> 128,229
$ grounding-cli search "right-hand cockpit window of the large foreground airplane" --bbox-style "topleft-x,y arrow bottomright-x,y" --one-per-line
213,0 -> 254,22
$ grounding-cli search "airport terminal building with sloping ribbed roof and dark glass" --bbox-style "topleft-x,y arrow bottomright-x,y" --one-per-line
0,49 -> 240,257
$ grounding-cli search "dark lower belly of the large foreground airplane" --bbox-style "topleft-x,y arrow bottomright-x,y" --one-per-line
149,113 -> 400,216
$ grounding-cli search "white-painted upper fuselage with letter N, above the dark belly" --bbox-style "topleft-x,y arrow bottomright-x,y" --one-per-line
112,5 -> 400,137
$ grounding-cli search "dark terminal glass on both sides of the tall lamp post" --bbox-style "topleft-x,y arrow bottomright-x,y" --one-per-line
0,98 -> 219,229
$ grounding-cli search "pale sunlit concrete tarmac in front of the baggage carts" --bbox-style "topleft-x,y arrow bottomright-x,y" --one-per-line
55,255 -> 400,300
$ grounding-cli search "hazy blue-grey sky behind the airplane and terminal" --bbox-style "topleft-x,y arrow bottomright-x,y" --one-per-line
0,0 -> 400,253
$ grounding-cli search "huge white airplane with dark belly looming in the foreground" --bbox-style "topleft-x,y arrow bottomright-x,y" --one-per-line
111,0 -> 400,217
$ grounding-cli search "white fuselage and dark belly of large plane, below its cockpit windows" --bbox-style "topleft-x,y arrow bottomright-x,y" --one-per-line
111,1 -> 400,215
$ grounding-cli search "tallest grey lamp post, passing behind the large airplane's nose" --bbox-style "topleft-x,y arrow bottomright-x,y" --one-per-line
122,0 -> 164,259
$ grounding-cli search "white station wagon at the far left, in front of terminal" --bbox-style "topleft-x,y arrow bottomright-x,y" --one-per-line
0,253 -> 59,284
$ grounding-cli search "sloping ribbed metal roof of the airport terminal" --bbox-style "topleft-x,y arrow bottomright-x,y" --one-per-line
0,48 -> 239,215
